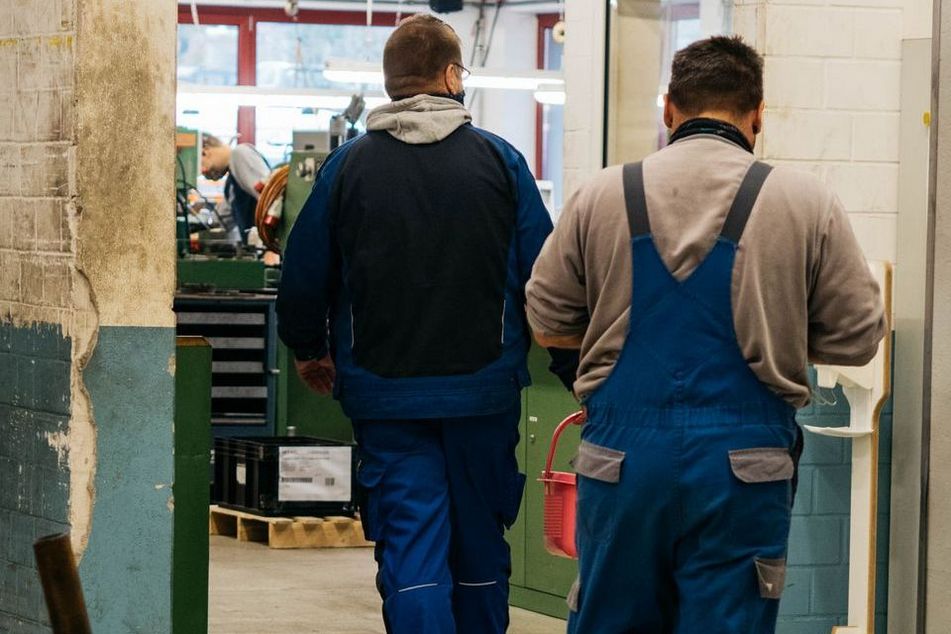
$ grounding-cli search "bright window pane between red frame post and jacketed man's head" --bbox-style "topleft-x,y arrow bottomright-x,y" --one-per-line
257,22 -> 394,90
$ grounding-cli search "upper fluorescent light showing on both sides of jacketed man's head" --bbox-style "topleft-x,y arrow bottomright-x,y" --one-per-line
324,59 -> 565,91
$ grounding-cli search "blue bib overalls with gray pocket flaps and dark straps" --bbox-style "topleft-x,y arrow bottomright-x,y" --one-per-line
568,163 -> 799,634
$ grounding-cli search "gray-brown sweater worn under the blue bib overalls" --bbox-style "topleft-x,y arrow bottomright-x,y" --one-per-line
526,135 -> 886,407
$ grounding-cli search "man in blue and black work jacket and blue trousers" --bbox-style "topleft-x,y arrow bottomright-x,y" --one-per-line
278,15 -> 552,634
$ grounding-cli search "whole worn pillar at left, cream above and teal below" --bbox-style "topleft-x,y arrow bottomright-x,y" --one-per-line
0,0 -> 177,632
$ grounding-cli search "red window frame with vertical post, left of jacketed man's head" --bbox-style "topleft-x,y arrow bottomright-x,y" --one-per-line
178,3 -> 402,143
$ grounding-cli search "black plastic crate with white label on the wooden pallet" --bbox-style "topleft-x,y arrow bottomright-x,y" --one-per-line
214,436 -> 356,516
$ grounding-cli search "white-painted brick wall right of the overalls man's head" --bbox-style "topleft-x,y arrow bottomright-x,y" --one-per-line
734,0 -> 903,261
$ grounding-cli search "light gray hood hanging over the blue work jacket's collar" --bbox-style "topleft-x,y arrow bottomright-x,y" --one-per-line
367,95 -> 472,145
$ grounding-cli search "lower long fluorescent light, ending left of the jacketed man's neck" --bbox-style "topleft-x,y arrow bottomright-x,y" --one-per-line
178,83 -> 389,110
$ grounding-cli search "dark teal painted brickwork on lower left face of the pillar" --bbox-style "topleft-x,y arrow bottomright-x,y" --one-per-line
0,324 -> 71,634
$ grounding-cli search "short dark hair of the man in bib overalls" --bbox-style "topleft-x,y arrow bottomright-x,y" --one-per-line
667,35 -> 763,116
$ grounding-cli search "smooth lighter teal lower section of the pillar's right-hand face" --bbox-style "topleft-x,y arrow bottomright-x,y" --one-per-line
80,327 -> 175,634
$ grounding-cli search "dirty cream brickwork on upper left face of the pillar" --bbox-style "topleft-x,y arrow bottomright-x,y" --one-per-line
0,0 -> 76,323
